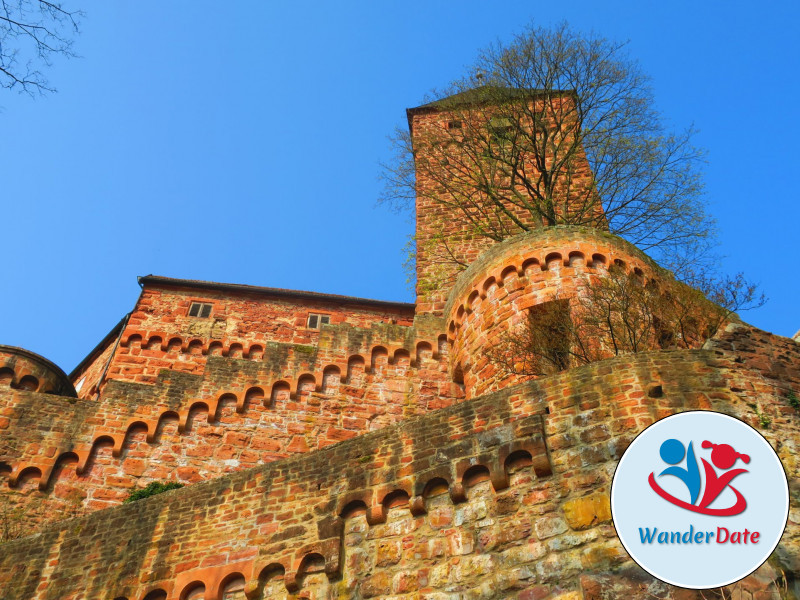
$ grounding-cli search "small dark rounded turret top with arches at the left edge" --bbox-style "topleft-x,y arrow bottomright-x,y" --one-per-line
0,344 -> 77,398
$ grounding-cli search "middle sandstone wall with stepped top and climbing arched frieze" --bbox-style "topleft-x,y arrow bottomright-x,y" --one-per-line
0,316 -> 463,533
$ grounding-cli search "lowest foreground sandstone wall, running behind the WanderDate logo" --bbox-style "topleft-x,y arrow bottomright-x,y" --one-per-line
0,325 -> 800,600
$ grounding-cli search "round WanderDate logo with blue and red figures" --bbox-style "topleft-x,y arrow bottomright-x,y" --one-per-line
611,411 -> 789,589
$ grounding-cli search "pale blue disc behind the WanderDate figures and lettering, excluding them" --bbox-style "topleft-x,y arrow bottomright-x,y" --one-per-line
611,411 -> 789,589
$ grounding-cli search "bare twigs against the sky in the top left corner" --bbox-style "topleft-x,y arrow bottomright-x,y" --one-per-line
0,0 -> 83,96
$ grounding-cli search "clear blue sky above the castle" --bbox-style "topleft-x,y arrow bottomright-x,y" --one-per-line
0,0 -> 800,371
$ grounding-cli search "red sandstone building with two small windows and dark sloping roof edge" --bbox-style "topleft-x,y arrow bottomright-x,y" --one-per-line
73,276 -> 414,397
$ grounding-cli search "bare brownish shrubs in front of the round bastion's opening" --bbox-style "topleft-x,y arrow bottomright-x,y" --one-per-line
487,266 -> 765,377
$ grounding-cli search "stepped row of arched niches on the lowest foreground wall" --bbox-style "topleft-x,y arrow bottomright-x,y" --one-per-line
101,436 -> 553,600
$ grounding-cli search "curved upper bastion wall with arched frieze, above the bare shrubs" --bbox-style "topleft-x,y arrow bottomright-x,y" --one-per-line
444,226 -> 662,398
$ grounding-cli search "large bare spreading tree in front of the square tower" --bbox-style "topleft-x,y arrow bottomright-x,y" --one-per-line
382,24 -> 714,272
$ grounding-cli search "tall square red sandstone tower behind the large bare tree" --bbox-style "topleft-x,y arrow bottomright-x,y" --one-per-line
407,86 -> 605,315
